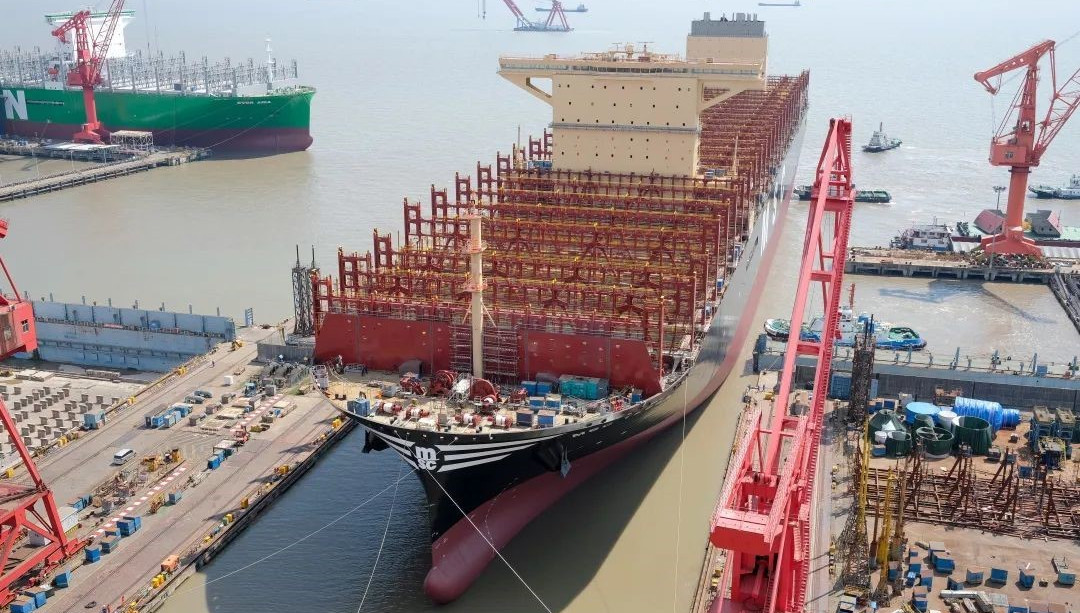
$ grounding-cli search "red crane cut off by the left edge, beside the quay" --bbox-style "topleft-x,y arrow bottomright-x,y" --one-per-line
0,219 -> 85,607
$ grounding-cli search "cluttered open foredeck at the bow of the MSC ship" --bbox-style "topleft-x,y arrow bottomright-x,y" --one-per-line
327,371 -> 631,434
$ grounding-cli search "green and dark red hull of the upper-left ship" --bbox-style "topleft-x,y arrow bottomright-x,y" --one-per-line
0,86 -> 315,153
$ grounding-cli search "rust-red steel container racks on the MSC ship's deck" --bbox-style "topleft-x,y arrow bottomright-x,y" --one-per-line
312,73 -> 808,395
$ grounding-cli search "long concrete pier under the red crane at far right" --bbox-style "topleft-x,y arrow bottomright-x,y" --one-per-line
843,247 -> 1080,284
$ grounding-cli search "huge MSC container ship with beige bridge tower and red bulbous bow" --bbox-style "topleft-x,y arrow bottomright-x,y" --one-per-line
311,13 -> 809,602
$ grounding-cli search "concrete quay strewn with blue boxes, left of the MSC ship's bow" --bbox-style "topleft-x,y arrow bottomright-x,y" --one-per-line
0,327 -> 354,611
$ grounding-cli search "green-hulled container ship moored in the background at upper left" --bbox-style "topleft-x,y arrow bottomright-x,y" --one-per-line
0,11 -> 315,154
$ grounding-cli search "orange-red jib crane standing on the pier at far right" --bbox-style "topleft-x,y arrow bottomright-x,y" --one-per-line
975,40 -> 1080,257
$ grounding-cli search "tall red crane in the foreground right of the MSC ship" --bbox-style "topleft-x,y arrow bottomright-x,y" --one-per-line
710,119 -> 854,613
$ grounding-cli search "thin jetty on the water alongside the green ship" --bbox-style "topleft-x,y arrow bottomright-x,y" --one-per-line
0,142 -> 210,202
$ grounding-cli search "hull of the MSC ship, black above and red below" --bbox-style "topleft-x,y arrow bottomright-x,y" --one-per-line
343,113 -> 804,600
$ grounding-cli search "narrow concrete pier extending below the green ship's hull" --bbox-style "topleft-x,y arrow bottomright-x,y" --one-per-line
0,140 -> 211,202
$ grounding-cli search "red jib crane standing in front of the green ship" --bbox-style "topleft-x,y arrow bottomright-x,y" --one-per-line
53,0 -> 124,144
